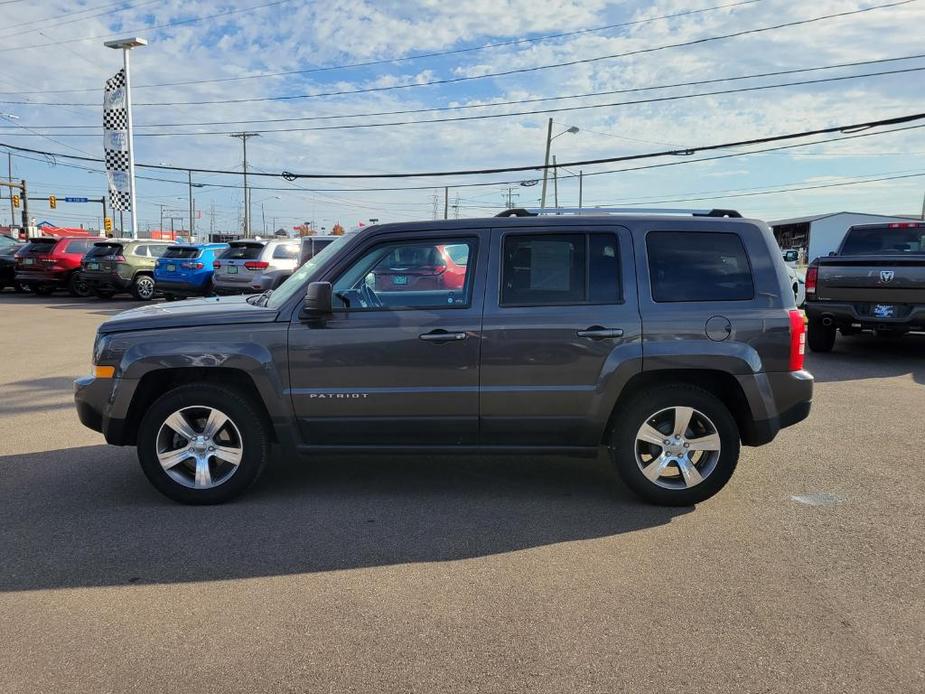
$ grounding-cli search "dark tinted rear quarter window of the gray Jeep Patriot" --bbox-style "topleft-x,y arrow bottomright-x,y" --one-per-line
646,231 -> 755,303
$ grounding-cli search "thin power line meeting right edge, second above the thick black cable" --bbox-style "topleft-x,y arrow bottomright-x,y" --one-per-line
9,53 -> 925,130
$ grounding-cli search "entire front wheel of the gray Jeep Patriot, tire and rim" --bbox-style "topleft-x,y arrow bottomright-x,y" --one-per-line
138,384 -> 269,504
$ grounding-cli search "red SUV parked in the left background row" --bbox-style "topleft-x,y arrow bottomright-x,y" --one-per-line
16,236 -> 99,296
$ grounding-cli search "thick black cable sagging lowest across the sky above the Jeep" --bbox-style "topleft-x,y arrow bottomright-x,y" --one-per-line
0,113 -> 925,182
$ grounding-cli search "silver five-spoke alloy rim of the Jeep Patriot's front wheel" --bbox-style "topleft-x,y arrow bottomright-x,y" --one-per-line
155,405 -> 244,489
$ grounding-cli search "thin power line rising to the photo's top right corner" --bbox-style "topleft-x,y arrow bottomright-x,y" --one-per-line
0,0 -> 919,107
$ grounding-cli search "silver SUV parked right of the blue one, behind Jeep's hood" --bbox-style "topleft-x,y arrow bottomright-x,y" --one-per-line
212,239 -> 299,294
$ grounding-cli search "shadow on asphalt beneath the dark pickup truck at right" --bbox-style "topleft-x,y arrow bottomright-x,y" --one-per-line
806,335 -> 925,385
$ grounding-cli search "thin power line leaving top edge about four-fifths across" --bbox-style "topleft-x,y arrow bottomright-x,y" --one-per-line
0,0 -> 763,94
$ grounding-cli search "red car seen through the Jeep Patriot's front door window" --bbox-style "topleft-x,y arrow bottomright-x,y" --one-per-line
373,243 -> 469,292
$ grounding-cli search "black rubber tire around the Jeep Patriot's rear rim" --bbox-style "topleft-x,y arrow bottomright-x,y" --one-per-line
610,384 -> 739,506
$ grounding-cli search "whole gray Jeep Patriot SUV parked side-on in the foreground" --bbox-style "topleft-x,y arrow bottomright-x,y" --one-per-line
75,210 -> 813,505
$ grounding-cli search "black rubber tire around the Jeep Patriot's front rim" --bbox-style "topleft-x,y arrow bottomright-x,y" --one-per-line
137,383 -> 269,504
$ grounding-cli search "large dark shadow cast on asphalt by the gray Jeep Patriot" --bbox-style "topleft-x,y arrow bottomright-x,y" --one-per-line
0,446 -> 692,591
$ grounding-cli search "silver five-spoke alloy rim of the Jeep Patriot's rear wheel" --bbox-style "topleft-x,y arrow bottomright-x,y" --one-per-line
635,407 -> 721,489
